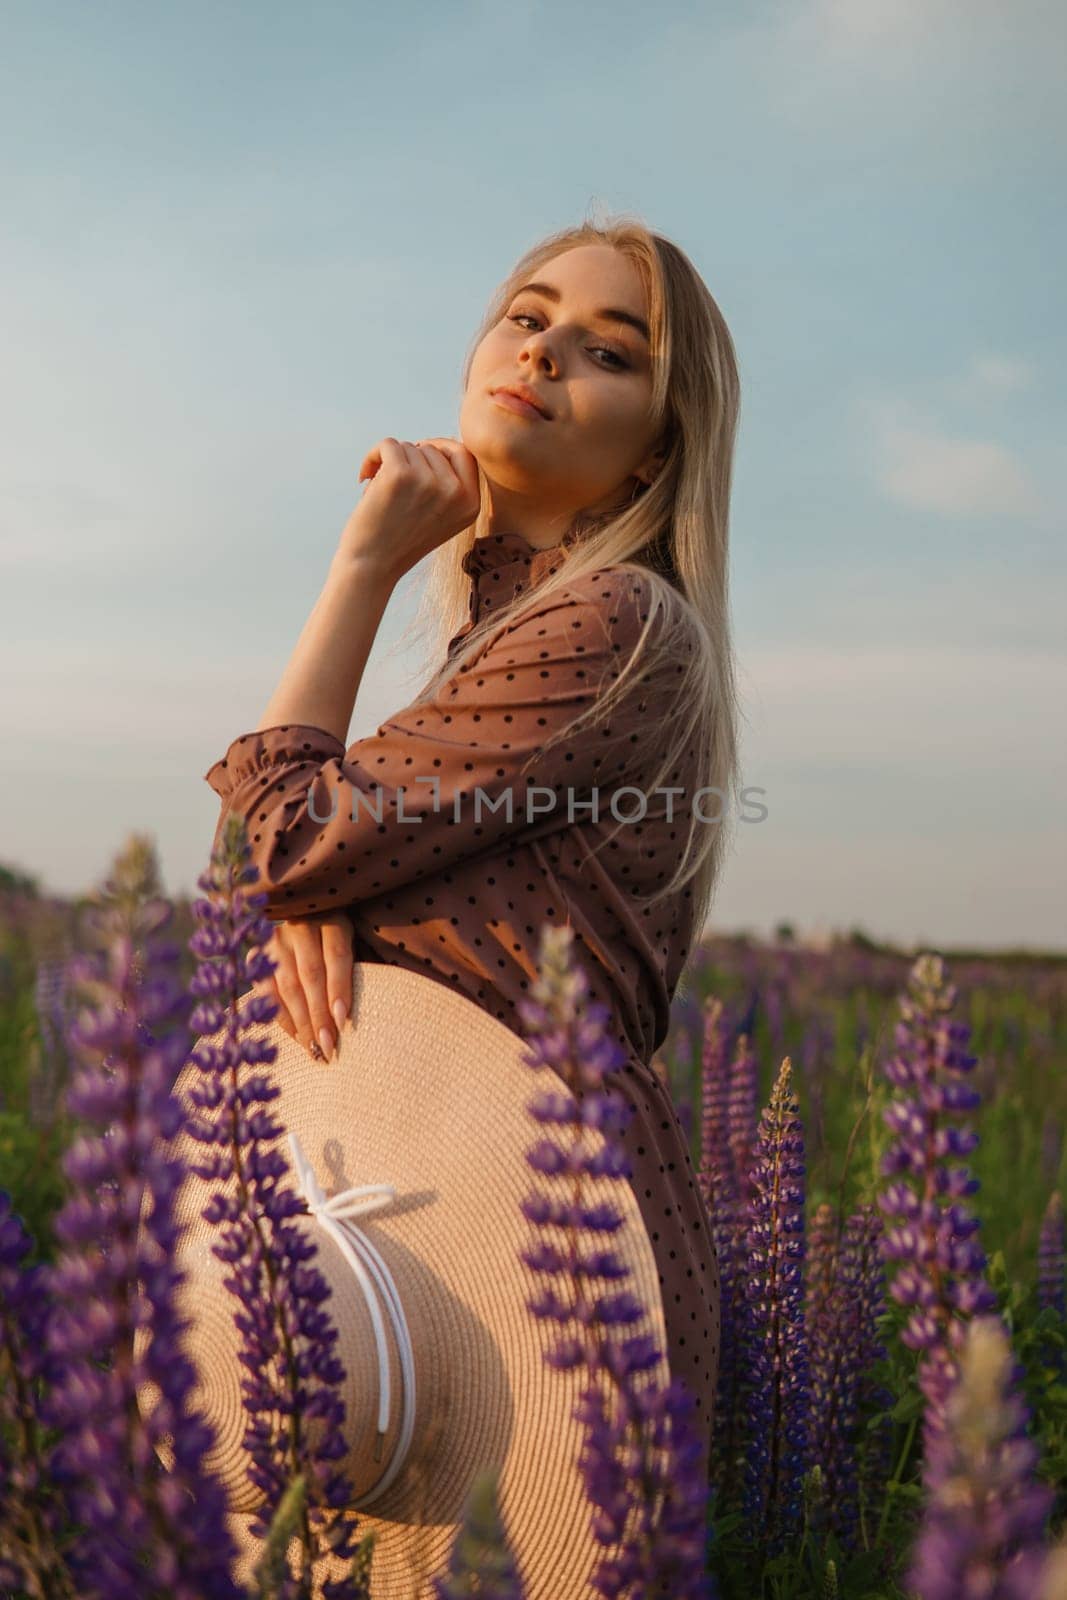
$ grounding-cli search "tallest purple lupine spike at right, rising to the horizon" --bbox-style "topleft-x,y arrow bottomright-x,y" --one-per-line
878,955 -> 997,1465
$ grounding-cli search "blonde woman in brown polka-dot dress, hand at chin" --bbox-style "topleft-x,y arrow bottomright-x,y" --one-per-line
206,221 -> 739,1497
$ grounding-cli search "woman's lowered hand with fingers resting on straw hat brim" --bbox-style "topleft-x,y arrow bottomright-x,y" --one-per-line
253,912 -> 354,1061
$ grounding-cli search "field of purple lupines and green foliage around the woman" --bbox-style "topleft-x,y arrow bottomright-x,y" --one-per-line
0,827 -> 1067,1600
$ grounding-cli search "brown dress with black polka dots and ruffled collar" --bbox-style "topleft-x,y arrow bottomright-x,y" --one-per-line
205,533 -> 720,1491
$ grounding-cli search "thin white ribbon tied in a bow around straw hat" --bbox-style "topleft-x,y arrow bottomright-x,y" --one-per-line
288,1131 -> 414,1506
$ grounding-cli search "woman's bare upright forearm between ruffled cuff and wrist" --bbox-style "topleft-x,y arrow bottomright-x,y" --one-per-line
256,550 -> 395,744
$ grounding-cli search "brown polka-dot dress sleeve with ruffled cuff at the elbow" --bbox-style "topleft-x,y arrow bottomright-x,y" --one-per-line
205,566 -> 675,922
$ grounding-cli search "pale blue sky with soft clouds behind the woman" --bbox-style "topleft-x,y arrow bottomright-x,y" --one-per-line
0,0 -> 1067,949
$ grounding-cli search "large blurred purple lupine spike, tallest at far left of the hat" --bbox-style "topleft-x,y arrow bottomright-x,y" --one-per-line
43,838 -> 240,1600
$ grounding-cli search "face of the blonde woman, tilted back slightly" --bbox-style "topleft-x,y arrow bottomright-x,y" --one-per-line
459,245 -> 662,546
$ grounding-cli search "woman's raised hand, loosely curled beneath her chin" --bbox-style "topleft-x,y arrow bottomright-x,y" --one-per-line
338,438 -> 482,582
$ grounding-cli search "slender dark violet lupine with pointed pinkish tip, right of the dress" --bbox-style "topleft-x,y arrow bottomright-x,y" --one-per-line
742,1056 -> 813,1555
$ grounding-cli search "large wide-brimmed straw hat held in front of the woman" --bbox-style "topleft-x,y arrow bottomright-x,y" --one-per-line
141,962 -> 670,1600
